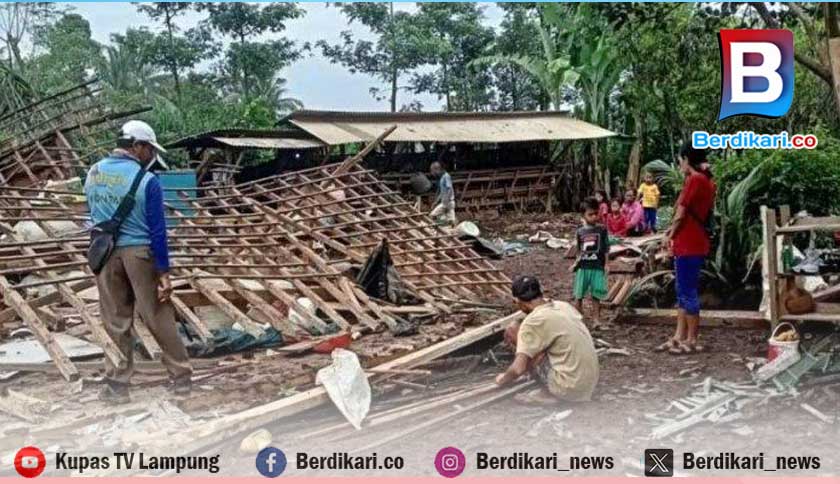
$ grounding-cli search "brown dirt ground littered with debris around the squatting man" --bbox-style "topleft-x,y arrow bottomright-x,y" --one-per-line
5,215 -> 840,476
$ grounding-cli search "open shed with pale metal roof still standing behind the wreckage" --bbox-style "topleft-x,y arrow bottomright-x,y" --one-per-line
167,111 -> 614,216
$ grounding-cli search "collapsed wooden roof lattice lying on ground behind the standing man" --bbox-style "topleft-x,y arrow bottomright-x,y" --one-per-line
0,109 -> 509,380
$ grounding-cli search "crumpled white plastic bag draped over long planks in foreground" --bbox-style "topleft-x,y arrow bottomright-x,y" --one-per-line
315,348 -> 370,430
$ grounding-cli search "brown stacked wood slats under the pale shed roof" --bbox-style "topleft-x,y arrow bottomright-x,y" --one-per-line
383,165 -> 559,213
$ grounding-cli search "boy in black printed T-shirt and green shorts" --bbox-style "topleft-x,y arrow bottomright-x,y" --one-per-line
574,198 -> 609,327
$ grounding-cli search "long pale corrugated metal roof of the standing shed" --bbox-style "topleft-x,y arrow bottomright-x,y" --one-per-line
284,111 -> 615,145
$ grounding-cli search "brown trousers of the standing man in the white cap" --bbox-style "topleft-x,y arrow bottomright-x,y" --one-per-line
96,246 -> 192,383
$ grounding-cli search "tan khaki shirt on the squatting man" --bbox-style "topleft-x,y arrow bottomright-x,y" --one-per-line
516,301 -> 599,401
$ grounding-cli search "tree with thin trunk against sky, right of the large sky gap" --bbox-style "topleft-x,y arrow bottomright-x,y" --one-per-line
316,3 -> 436,112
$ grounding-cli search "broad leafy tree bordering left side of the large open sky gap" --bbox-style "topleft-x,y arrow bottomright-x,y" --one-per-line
199,3 -> 304,97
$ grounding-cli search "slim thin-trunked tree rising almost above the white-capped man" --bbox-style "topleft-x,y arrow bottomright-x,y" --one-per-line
135,2 -> 215,99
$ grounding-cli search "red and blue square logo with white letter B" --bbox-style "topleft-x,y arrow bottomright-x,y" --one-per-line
718,29 -> 794,120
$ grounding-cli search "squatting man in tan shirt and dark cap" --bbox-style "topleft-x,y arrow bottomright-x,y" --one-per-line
496,276 -> 599,403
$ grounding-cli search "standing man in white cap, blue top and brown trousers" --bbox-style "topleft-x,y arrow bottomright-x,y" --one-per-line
85,121 -> 192,403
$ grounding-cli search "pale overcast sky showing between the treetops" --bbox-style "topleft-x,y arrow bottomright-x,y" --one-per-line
72,2 -> 501,111
